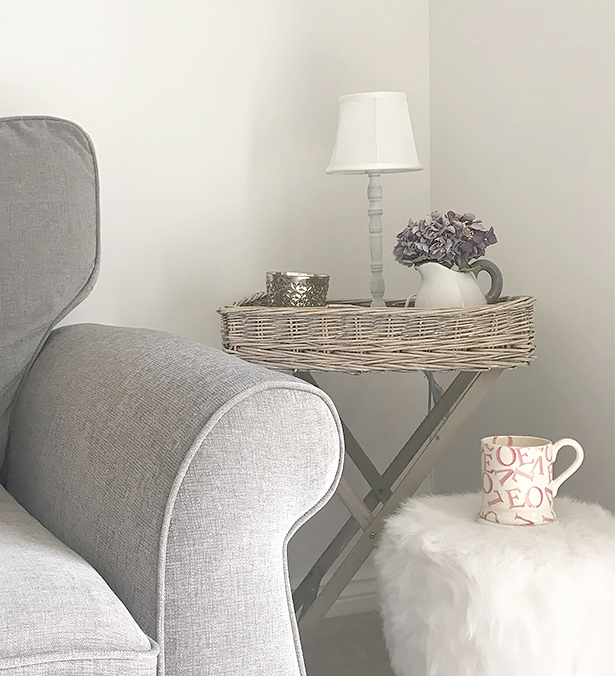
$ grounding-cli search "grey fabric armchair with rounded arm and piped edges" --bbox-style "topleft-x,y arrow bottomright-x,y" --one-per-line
0,117 -> 342,676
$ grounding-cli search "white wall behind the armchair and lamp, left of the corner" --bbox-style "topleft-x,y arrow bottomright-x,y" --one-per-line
0,0 -> 429,612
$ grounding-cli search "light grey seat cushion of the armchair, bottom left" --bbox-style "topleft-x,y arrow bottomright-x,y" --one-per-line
0,486 -> 158,676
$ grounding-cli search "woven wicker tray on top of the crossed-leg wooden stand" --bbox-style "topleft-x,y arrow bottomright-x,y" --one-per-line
218,294 -> 536,373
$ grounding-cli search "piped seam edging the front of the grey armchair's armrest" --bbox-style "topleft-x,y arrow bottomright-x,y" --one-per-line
156,381 -> 344,676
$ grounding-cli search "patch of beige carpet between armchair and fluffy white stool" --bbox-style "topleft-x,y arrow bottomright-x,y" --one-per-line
304,612 -> 393,676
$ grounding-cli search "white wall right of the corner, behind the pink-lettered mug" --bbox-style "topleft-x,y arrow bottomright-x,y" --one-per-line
430,0 -> 615,509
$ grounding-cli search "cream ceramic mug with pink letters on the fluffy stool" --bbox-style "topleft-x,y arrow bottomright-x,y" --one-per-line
478,436 -> 583,526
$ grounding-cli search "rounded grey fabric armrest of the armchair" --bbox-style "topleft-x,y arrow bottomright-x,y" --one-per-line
7,325 -> 343,676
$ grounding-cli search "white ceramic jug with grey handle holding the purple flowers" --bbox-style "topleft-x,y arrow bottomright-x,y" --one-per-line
415,259 -> 503,308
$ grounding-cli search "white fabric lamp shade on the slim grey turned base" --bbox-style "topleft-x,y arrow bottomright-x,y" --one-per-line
327,92 -> 423,174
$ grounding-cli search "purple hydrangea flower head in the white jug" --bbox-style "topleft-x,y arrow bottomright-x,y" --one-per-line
393,211 -> 498,271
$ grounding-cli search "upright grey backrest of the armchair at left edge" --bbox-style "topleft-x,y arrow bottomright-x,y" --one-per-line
0,117 -> 99,466
